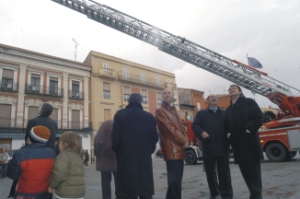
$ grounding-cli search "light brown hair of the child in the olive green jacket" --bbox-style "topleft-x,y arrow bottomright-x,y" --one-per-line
60,131 -> 82,154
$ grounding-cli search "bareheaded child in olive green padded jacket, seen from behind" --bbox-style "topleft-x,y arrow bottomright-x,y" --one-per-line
48,131 -> 85,199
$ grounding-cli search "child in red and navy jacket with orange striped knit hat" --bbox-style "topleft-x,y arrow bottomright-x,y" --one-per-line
7,126 -> 55,199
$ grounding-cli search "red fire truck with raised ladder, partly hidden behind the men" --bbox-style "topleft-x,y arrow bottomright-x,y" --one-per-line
52,0 -> 300,163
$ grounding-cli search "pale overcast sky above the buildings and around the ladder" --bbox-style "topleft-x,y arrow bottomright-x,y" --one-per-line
0,0 -> 300,107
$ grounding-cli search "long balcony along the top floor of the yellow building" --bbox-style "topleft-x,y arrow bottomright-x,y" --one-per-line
117,71 -> 166,88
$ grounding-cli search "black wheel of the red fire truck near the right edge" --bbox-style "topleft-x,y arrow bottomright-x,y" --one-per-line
266,143 -> 287,162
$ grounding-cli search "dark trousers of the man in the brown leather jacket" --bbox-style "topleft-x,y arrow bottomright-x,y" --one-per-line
166,160 -> 183,199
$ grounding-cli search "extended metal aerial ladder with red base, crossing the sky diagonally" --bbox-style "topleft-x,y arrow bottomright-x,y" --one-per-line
52,0 -> 300,128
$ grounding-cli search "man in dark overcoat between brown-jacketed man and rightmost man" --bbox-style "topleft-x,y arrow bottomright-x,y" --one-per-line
192,94 -> 233,199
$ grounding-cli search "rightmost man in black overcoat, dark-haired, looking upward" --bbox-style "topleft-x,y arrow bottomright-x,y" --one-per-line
225,85 -> 264,199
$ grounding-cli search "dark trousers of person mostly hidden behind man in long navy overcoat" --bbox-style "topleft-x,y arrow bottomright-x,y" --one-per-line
101,171 -> 117,199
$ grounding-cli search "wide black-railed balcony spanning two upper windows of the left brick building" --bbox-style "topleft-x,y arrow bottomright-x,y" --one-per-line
25,84 -> 64,98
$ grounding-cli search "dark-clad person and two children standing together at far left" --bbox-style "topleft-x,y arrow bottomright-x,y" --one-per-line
7,103 -> 85,199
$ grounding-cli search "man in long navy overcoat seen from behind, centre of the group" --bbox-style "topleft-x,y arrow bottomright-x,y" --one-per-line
111,93 -> 158,199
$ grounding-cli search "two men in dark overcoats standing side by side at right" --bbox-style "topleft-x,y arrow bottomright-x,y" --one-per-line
192,85 -> 264,199
